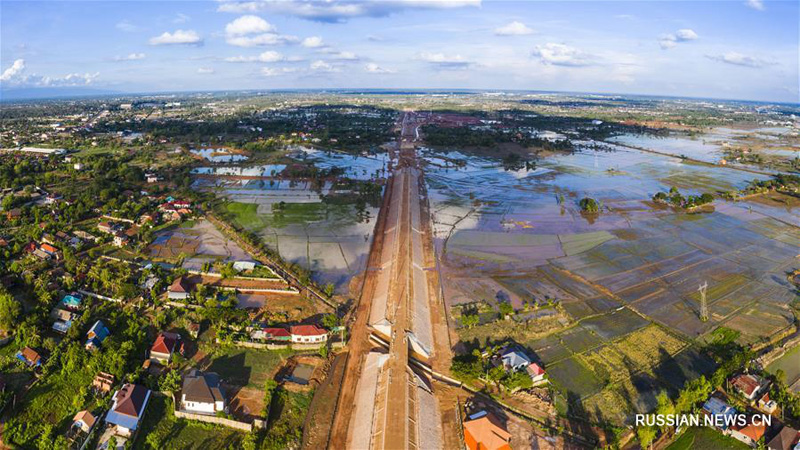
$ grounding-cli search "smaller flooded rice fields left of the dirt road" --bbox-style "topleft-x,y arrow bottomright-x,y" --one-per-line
193,147 -> 388,293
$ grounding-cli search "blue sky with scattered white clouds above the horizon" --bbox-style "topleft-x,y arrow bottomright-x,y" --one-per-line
0,0 -> 800,103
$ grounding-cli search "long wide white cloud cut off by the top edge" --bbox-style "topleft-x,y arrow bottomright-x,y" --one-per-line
217,0 -> 481,23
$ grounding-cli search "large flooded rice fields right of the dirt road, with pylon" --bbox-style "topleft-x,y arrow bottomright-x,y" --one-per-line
423,142 -> 800,423
